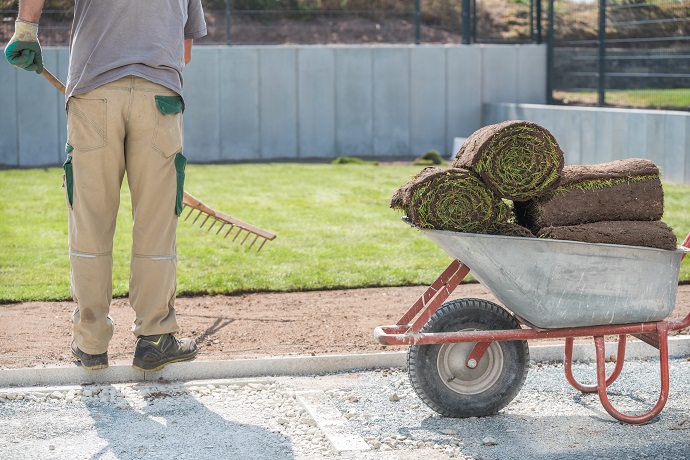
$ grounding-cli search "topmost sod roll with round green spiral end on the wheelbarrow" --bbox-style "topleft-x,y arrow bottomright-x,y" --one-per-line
453,120 -> 564,201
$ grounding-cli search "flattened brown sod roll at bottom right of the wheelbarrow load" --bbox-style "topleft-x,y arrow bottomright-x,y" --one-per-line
537,221 -> 677,251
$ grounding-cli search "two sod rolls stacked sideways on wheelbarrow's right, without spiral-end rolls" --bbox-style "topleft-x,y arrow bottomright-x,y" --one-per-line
514,158 -> 677,250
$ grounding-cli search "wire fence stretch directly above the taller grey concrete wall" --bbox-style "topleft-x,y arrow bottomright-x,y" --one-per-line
0,0 -> 541,46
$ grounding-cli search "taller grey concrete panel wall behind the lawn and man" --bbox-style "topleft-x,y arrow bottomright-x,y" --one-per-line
0,45 -> 546,167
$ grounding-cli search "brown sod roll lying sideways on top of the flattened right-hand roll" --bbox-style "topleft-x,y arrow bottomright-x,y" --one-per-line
514,158 -> 664,233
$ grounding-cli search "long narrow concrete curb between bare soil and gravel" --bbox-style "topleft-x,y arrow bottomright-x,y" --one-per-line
0,336 -> 690,388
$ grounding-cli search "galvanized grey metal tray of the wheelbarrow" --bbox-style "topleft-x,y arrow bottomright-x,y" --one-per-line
420,229 -> 685,329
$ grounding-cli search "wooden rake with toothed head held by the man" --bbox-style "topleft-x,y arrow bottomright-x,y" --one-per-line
41,68 -> 276,252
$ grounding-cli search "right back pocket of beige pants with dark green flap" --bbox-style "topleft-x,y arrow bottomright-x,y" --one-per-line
151,96 -> 184,158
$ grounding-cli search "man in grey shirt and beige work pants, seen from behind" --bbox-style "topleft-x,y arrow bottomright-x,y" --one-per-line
5,0 -> 206,371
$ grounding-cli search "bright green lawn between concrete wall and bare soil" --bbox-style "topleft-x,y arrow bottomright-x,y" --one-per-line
0,163 -> 690,303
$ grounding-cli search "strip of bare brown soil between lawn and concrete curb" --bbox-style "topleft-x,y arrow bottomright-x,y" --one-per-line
0,283 -> 690,369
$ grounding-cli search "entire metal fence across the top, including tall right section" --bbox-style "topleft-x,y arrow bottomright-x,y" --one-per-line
0,0 -> 690,110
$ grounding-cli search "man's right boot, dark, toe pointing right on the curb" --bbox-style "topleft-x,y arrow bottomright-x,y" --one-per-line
132,334 -> 197,372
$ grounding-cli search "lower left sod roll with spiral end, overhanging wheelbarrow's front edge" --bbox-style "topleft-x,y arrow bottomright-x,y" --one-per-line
390,166 -> 510,233
